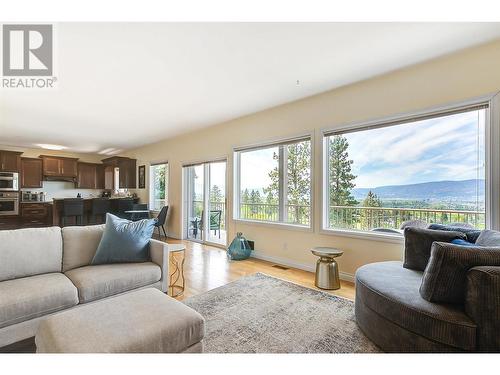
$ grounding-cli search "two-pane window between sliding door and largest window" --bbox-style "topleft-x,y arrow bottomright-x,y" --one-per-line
234,138 -> 311,227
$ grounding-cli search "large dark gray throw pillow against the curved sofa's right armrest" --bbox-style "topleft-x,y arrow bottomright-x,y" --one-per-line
420,242 -> 500,304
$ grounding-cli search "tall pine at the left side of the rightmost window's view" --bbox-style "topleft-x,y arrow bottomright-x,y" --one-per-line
328,135 -> 358,206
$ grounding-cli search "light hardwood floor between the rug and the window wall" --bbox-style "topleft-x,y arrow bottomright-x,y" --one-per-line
164,238 -> 354,300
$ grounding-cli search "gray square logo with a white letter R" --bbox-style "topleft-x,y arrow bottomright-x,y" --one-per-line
2,25 -> 53,76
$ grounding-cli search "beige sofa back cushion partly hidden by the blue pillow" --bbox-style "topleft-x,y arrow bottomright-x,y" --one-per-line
62,224 -> 104,272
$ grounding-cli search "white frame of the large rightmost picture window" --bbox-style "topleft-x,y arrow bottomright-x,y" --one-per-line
320,93 -> 500,243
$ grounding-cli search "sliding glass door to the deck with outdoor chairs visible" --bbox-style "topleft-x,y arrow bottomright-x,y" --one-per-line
183,160 -> 226,246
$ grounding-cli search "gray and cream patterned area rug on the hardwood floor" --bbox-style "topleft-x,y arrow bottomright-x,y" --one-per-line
183,273 -> 379,353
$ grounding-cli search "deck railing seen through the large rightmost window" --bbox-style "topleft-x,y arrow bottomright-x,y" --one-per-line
329,206 -> 485,230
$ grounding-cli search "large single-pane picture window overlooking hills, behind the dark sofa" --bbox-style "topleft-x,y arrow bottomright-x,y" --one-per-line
323,106 -> 487,234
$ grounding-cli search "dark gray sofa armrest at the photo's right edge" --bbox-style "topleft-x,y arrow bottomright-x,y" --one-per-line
465,266 -> 500,352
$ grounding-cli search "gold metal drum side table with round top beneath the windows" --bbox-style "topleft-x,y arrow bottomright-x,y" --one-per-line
311,247 -> 344,290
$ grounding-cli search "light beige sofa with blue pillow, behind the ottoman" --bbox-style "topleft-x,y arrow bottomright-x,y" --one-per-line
0,225 -> 169,347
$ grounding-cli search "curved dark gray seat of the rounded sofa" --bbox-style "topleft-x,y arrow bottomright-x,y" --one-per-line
356,262 -> 476,350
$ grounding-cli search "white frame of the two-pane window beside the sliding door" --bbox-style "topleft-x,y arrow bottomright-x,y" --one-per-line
232,132 -> 316,232
